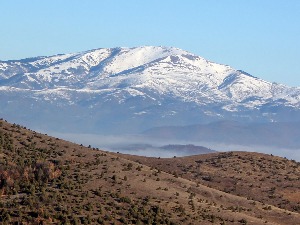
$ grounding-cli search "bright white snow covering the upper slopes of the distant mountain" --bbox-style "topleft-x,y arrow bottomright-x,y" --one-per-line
0,46 -> 300,109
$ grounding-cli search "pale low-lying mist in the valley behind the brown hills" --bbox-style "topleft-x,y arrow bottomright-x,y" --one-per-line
48,132 -> 300,162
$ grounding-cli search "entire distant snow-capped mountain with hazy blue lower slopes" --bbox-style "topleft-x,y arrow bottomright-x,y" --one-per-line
0,46 -> 300,133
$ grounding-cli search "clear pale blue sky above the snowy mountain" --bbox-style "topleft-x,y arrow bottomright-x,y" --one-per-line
0,0 -> 300,86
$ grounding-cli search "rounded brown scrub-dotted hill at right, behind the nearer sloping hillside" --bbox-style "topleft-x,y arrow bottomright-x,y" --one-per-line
124,152 -> 300,213
